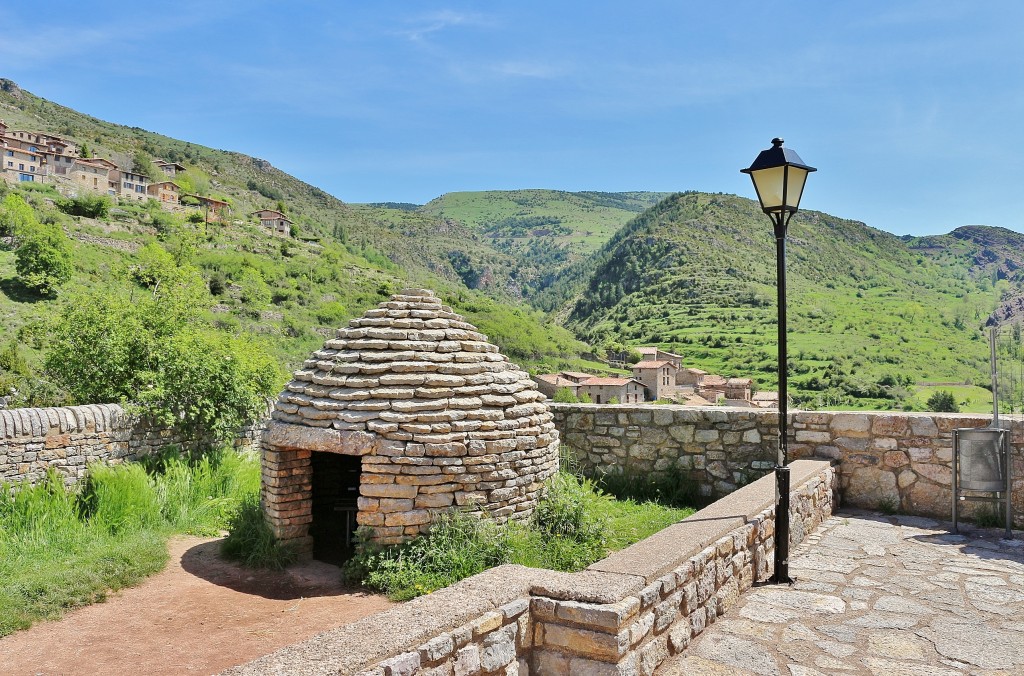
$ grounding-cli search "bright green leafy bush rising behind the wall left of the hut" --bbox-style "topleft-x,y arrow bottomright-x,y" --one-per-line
45,245 -> 281,438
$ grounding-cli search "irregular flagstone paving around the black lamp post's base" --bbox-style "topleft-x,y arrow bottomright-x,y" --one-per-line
656,511 -> 1024,676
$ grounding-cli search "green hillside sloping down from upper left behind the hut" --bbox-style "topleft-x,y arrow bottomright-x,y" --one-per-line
0,81 -> 587,407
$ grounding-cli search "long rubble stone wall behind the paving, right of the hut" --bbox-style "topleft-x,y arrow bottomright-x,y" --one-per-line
549,404 -> 1024,525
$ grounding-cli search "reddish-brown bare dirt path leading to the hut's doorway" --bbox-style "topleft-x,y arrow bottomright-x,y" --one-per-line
0,538 -> 390,676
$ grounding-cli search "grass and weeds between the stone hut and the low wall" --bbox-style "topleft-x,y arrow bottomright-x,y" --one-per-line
345,472 -> 693,600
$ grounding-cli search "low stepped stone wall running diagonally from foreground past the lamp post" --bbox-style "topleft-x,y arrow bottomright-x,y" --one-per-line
225,460 -> 838,676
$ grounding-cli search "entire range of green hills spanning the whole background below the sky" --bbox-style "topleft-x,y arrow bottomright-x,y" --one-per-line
0,80 -> 1024,408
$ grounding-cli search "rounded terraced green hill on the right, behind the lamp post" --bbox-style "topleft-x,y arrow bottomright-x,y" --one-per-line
553,193 -> 1024,408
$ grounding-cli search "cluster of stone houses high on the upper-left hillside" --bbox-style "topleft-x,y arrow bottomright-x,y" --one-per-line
0,120 -> 292,238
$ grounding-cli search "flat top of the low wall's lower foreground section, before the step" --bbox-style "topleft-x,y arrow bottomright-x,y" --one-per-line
221,564 -> 565,676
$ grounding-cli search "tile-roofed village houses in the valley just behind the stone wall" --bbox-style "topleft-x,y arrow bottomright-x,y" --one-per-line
537,346 -> 778,409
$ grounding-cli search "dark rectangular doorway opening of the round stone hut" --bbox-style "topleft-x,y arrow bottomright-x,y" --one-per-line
309,452 -> 362,565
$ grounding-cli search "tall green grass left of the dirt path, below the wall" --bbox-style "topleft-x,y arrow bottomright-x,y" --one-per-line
0,451 -> 259,636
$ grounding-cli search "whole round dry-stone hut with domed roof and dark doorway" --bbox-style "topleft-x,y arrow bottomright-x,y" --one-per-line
262,289 -> 558,560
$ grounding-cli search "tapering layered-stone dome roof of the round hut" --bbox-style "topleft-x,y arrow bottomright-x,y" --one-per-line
273,289 -> 547,430
